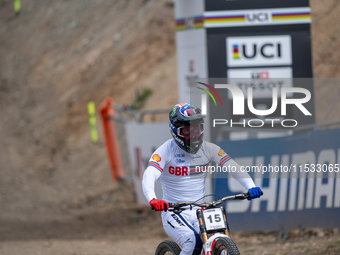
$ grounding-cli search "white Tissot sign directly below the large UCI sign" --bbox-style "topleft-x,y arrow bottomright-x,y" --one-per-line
227,67 -> 293,99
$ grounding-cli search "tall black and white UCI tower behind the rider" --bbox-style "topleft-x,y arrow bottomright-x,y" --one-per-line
175,0 -> 315,143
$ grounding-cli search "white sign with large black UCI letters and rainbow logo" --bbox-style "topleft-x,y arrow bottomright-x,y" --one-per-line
226,35 -> 292,67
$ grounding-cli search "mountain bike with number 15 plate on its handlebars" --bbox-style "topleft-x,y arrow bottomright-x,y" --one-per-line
155,192 -> 263,255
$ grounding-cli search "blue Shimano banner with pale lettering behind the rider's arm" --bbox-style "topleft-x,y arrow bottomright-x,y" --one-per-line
214,129 -> 340,231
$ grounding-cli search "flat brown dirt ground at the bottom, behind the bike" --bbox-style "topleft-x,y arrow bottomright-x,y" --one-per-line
0,184 -> 340,255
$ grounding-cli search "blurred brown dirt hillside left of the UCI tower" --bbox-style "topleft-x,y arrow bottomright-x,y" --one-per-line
0,0 -> 177,217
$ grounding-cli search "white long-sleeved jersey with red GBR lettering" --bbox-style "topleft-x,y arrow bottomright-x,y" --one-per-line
142,139 -> 255,202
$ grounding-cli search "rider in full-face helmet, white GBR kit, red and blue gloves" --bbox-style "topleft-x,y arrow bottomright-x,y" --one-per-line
142,103 -> 261,255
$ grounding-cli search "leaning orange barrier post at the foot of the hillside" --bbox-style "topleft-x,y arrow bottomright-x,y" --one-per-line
99,98 -> 125,180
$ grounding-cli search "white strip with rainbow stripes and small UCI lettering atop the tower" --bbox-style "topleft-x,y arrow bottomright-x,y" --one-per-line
204,7 -> 311,28
